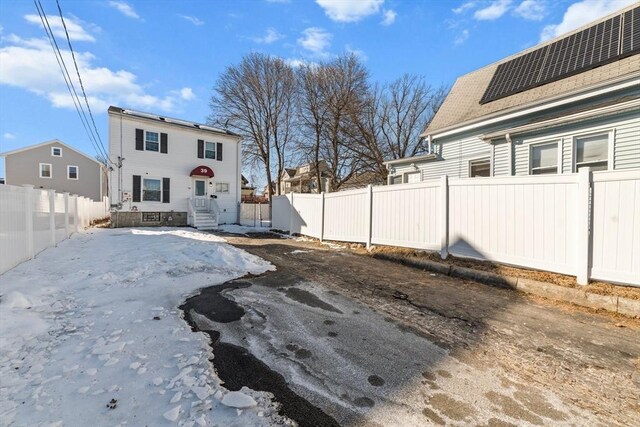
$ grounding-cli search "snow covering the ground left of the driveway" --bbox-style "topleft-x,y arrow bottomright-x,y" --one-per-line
0,228 -> 282,426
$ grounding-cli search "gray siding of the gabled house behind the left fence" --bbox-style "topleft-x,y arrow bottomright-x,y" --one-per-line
5,142 -> 106,201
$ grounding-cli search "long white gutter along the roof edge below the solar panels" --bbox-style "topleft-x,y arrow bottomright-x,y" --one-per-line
420,72 -> 640,139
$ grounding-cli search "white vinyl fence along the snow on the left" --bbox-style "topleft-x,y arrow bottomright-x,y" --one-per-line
0,185 -> 109,274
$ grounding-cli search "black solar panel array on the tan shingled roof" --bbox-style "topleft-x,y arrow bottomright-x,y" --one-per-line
480,7 -> 640,104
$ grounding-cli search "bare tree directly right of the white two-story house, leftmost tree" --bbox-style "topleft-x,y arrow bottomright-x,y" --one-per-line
209,53 -> 296,202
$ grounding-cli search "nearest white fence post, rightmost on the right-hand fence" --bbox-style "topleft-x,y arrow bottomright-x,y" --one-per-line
576,167 -> 592,285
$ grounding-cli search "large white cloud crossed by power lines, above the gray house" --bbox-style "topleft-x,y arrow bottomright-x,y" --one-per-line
0,34 -> 195,112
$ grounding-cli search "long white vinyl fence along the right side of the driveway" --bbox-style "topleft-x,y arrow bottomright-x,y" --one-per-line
273,169 -> 640,286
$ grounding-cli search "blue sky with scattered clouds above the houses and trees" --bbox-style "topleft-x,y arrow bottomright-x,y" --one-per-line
0,0 -> 635,177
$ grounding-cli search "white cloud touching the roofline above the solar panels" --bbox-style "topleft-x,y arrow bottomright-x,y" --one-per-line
540,0 -> 637,41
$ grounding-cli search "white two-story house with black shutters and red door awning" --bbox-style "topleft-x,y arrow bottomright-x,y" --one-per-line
108,106 -> 242,229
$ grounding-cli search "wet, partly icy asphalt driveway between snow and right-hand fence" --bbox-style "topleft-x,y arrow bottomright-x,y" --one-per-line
182,235 -> 640,426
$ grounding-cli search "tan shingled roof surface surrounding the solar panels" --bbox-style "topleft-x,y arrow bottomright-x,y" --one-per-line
423,4 -> 640,136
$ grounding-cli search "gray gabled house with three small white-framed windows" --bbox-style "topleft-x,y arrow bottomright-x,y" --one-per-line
0,139 -> 108,201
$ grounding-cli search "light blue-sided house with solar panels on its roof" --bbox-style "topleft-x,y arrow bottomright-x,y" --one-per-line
386,4 -> 640,184
